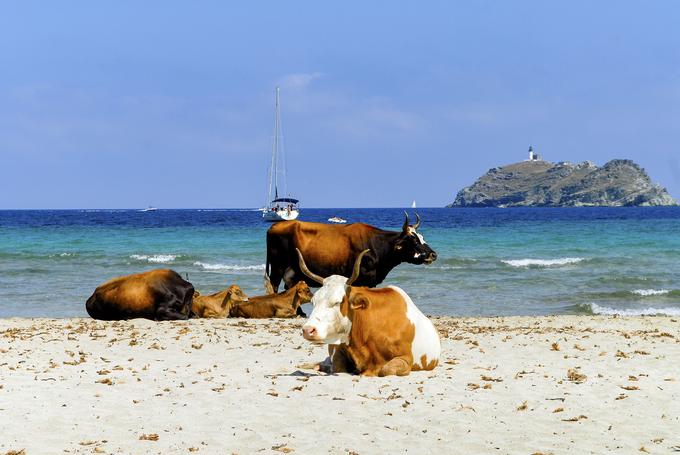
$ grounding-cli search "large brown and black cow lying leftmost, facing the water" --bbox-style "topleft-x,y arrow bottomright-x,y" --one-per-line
85,269 -> 194,321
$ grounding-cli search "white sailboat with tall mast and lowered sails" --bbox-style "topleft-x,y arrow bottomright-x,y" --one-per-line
262,87 -> 300,221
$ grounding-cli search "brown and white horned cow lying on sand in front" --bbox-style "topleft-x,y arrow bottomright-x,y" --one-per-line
297,250 -> 441,376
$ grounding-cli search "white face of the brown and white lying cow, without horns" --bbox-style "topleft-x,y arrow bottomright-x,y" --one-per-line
302,275 -> 352,344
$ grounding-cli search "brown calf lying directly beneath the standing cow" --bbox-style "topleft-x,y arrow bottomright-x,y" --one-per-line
229,281 -> 312,318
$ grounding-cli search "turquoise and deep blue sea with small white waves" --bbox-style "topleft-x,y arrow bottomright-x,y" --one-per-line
0,207 -> 680,318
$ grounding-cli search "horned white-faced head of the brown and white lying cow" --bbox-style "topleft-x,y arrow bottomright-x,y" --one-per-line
297,250 -> 370,344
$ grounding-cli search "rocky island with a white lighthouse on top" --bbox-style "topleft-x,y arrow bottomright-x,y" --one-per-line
447,155 -> 677,207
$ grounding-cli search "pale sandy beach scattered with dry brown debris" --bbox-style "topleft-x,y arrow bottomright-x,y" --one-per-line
0,316 -> 680,454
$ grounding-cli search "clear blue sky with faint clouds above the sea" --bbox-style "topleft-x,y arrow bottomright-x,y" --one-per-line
0,0 -> 680,209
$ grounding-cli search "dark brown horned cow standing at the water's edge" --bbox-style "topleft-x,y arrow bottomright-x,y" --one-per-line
265,213 -> 437,293
